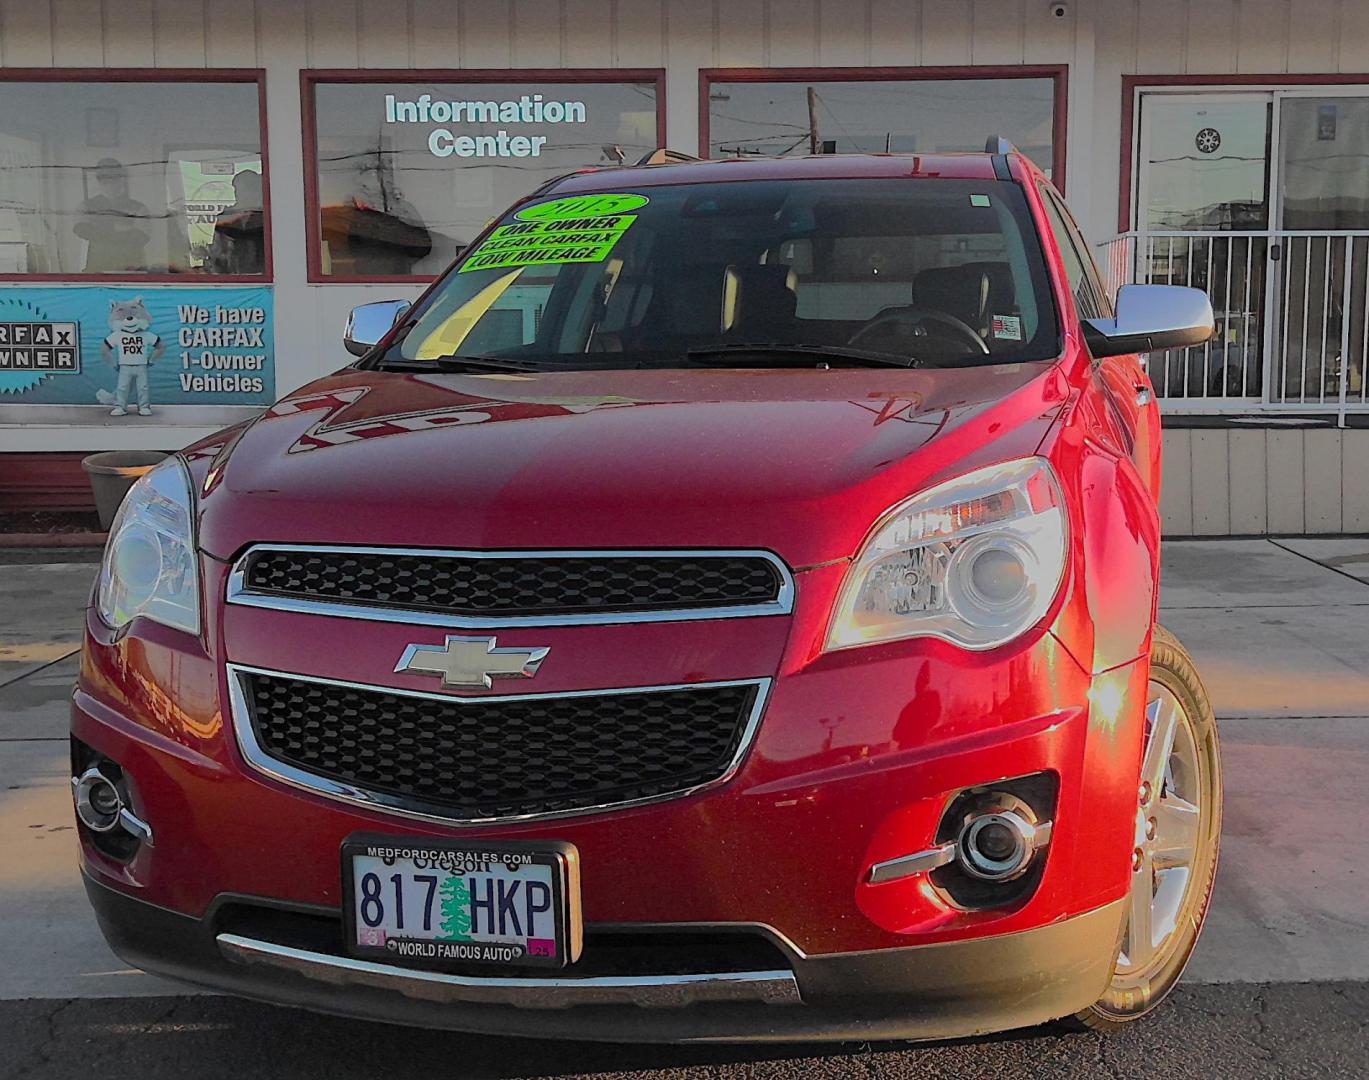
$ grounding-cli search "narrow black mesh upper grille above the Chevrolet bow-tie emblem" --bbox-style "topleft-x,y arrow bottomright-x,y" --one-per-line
230,548 -> 786,620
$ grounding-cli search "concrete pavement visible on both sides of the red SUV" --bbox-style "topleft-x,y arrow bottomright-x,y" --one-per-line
0,539 -> 1369,999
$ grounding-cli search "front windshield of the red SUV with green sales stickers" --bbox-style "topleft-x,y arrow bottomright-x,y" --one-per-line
381,178 -> 1058,370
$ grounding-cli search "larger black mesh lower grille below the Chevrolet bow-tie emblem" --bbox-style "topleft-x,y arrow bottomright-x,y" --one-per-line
234,669 -> 763,820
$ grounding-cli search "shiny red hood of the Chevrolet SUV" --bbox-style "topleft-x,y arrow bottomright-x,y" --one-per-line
188,364 -> 1065,567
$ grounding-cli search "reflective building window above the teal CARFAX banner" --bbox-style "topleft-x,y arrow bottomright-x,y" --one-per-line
0,70 -> 271,281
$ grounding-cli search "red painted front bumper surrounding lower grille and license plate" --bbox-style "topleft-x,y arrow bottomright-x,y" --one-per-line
71,588 -> 1146,955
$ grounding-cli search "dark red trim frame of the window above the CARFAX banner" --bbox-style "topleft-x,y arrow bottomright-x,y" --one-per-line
0,67 -> 275,286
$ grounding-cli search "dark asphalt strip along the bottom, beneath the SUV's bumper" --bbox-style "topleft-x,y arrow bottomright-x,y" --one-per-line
8,983 -> 1369,1080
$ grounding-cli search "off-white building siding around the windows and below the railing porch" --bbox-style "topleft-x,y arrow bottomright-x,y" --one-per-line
0,0 -> 1369,534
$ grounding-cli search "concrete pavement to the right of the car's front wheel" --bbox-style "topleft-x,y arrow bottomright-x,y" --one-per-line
1161,539 -> 1369,981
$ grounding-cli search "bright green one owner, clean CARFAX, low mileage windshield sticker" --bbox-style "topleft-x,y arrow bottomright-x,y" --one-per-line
459,194 -> 649,274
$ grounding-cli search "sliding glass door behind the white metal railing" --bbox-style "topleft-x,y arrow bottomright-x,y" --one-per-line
1136,86 -> 1369,408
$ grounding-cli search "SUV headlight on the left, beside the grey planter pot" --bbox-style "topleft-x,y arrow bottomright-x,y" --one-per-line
96,457 -> 200,634
